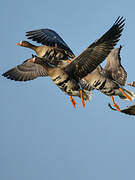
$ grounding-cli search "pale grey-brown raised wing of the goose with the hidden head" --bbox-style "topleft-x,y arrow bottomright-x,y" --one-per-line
103,46 -> 127,86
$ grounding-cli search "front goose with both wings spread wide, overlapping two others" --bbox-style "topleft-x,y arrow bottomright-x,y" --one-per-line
3,17 -> 125,107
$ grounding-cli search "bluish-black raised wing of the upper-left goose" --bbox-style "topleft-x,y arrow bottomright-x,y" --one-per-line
26,29 -> 74,58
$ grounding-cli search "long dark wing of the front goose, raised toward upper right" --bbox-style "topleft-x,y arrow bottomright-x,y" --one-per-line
65,17 -> 125,79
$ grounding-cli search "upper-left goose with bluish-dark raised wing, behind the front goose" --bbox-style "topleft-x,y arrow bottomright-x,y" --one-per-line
16,29 -> 75,65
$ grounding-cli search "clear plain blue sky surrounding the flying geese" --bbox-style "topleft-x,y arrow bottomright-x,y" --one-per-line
0,0 -> 135,180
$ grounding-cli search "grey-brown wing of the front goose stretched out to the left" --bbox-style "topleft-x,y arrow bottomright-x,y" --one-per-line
2,58 -> 47,81
